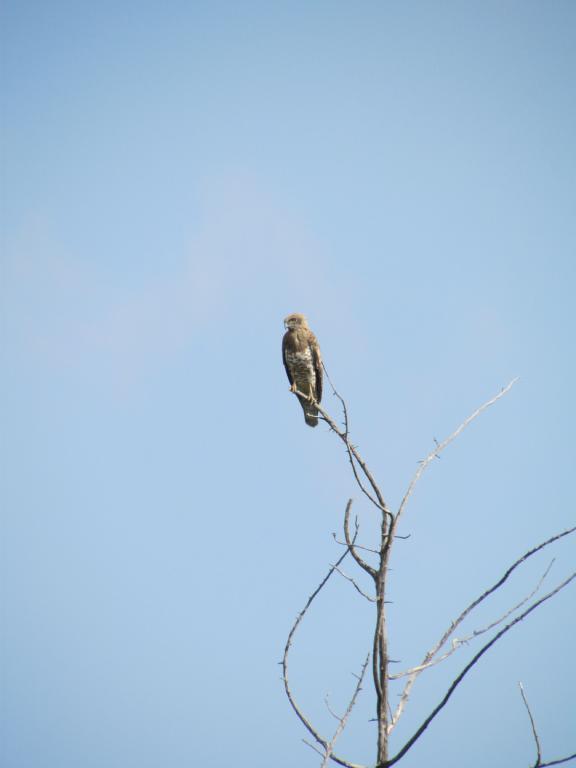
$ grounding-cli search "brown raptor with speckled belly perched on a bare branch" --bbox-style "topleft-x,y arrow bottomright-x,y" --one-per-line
282,312 -> 322,427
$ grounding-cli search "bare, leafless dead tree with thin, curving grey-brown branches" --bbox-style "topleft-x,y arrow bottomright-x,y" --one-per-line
282,378 -> 576,768
